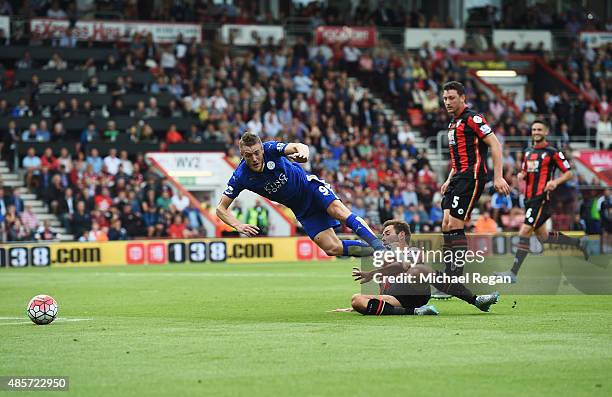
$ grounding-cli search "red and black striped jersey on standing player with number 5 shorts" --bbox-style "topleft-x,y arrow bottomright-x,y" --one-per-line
448,107 -> 493,179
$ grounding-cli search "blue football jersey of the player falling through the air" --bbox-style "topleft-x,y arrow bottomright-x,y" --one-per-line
223,141 -> 318,217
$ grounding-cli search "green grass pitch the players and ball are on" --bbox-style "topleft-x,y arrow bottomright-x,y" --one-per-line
0,261 -> 612,397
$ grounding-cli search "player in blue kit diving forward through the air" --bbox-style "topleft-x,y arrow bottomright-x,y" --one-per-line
217,132 -> 385,256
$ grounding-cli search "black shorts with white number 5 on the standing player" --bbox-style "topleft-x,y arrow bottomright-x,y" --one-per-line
442,178 -> 485,221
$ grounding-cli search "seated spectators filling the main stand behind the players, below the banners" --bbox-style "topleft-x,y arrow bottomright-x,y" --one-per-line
0,2 -> 610,241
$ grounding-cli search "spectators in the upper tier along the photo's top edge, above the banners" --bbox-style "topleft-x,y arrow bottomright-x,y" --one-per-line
0,0 -> 612,31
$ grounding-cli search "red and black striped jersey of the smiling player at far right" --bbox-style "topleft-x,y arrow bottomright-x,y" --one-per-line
521,143 -> 570,200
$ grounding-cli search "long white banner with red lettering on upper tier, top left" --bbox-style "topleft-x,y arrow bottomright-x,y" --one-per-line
30,18 -> 202,43
